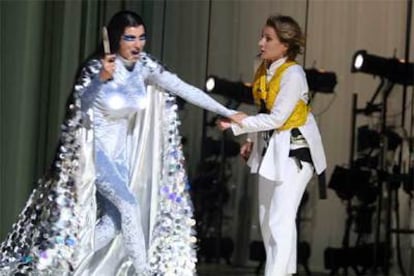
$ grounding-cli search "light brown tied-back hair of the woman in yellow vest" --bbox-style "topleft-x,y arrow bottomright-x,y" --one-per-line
266,15 -> 305,60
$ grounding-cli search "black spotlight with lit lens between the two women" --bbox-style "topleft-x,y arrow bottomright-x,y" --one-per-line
205,75 -> 254,104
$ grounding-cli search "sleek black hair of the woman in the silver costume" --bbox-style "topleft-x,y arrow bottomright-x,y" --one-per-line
107,10 -> 145,53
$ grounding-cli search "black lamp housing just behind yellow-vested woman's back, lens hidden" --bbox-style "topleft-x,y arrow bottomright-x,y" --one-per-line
305,68 -> 337,93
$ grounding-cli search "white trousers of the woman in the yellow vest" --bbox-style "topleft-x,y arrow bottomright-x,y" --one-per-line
259,158 -> 313,276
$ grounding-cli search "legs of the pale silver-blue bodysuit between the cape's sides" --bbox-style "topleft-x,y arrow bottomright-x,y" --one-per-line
95,148 -> 146,273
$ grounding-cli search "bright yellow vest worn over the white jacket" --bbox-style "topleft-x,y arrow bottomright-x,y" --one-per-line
252,61 -> 310,130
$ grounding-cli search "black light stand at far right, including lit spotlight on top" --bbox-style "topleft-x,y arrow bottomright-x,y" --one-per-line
350,50 -> 414,275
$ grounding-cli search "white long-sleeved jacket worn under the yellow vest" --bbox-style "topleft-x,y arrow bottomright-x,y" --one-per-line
231,58 -> 326,181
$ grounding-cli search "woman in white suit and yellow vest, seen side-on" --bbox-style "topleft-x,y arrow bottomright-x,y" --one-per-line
218,16 -> 326,276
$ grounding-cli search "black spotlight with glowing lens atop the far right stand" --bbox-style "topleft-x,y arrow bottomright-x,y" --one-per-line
351,50 -> 414,85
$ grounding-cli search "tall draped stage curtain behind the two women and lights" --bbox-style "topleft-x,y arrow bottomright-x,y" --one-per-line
0,0 -> 414,271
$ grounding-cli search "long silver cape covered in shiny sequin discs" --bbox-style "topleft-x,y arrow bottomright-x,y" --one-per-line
0,59 -> 196,276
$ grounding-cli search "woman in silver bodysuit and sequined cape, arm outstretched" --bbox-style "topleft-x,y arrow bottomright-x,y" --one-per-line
0,11 -> 235,275
